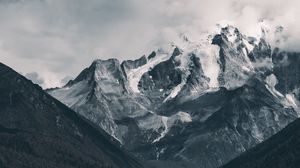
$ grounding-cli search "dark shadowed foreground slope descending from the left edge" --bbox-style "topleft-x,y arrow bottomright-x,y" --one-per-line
0,63 -> 142,168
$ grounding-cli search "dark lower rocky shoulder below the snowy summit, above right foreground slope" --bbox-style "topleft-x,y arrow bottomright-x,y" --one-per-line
149,79 -> 298,167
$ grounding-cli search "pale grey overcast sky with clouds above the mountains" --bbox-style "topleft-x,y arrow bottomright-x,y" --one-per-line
0,0 -> 300,88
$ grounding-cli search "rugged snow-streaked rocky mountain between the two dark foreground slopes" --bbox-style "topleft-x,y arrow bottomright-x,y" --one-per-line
48,26 -> 299,168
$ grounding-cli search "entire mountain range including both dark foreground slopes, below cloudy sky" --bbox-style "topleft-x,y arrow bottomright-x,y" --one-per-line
0,22 -> 300,168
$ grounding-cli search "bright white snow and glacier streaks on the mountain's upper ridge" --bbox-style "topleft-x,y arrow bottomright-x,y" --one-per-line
127,21 -> 264,95
